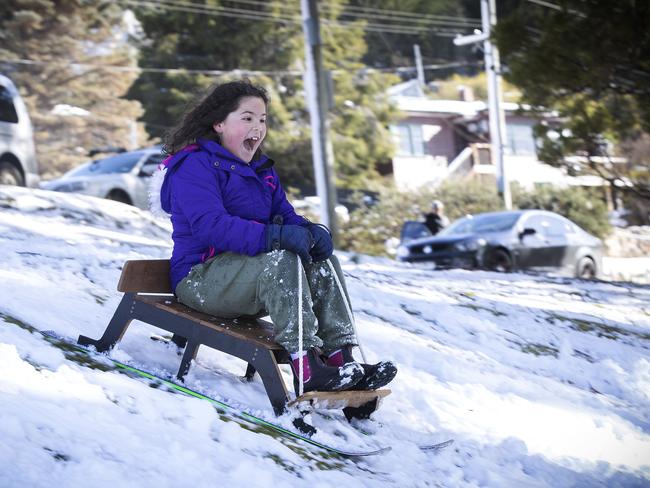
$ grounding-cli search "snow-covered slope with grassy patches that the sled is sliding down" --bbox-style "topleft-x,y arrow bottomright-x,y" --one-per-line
0,187 -> 650,488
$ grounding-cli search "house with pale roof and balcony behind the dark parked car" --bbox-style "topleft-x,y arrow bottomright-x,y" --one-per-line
388,80 -> 603,190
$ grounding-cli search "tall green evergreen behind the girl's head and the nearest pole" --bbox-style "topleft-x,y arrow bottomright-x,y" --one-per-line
130,0 -> 395,192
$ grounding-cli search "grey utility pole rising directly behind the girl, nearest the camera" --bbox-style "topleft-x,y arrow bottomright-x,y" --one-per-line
300,0 -> 338,239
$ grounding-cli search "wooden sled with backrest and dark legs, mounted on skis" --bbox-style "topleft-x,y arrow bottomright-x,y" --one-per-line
78,259 -> 390,419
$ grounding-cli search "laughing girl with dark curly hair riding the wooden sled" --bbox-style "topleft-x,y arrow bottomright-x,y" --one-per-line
154,80 -> 397,395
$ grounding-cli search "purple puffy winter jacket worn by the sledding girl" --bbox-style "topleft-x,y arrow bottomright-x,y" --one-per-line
160,139 -> 308,290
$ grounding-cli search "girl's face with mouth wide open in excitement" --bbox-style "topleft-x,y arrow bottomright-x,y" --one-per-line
213,97 -> 266,163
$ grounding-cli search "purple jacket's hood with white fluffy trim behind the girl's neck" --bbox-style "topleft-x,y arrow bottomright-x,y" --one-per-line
149,139 -> 273,215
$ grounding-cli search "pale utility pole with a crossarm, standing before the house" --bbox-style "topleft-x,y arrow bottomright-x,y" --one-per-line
454,0 -> 512,210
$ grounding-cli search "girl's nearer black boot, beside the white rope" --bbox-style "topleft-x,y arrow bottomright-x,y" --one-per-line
291,348 -> 363,395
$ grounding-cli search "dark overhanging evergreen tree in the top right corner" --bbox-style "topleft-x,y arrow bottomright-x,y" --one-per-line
496,0 -> 650,218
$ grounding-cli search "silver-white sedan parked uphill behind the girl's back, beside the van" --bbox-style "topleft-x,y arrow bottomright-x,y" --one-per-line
41,146 -> 165,209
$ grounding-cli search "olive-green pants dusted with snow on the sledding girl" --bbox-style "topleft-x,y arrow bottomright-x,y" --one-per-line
176,250 -> 357,353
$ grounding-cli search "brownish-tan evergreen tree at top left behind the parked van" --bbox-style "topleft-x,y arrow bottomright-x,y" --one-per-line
0,0 -> 140,178
